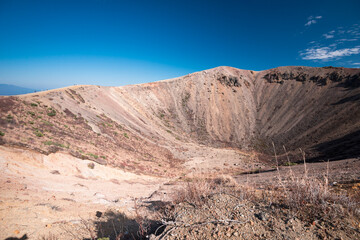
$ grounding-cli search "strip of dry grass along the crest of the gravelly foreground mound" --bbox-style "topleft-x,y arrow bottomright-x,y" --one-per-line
173,156 -> 360,217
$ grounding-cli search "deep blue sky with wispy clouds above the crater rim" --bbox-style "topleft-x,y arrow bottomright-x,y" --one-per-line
0,0 -> 360,89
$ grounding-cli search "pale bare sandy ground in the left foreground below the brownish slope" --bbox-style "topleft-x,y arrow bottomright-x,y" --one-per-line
0,146 -> 167,239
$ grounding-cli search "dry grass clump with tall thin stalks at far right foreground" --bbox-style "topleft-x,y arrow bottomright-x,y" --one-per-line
271,147 -> 359,215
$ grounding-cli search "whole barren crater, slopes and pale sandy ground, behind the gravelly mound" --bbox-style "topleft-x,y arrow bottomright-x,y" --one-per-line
0,67 -> 360,239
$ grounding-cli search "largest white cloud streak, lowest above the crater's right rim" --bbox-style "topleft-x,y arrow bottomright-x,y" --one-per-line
300,46 -> 360,60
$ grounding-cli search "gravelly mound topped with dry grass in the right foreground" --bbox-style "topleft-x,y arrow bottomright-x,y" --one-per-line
157,164 -> 359,239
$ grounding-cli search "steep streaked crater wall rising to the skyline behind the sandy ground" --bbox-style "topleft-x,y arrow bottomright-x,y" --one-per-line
0,67 -> 360,172
